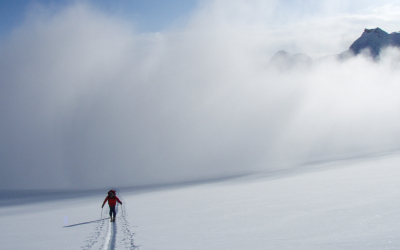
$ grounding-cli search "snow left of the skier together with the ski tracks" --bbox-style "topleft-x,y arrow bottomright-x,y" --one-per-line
0,192 -> 135,250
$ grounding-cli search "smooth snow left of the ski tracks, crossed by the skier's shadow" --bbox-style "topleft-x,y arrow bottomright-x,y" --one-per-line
0,194 -> 101,249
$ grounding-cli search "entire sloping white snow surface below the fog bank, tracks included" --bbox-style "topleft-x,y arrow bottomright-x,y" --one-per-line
0,155 -> 400,250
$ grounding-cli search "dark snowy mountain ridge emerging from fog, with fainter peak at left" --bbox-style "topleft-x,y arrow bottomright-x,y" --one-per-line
269,27 -> 400,65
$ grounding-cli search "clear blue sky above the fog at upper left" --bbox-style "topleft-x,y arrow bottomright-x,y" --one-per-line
0,0 -> 198,37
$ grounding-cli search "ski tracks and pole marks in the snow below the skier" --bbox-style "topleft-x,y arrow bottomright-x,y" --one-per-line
82,191 -> 139,250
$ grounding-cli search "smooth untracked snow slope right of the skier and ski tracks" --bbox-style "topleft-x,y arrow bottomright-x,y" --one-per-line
126,156 -> 400,250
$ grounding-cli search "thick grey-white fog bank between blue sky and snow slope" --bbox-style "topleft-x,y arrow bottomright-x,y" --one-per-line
0,0 -> 400,189
